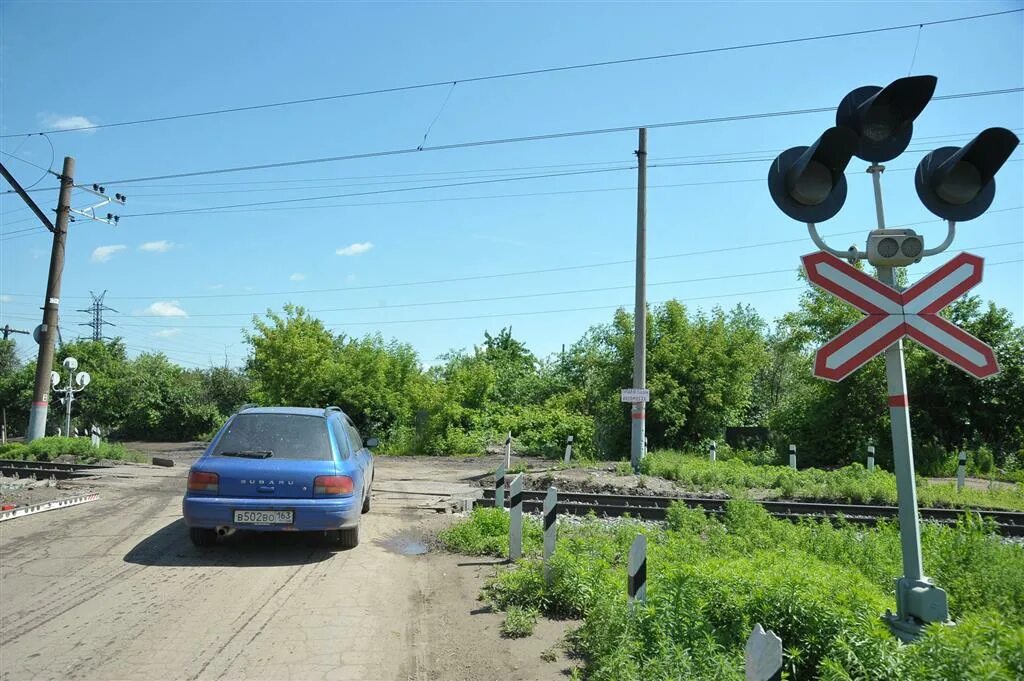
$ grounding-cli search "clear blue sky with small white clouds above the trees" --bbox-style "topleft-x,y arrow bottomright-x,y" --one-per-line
0,0 -> 1024,367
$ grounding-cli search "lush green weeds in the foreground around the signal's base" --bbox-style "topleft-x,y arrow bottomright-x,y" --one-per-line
439,500 -> 1024,681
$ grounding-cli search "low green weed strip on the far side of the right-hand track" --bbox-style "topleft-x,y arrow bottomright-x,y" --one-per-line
640,451 -> 1024,511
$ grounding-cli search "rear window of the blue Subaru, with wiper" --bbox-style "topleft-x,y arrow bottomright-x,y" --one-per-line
213,414 -> 334,461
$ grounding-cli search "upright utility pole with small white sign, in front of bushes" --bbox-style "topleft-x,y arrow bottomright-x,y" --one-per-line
630,128 -> 647,470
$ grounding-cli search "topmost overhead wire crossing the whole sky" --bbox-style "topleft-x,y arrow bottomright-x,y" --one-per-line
0,9 -> 1024,138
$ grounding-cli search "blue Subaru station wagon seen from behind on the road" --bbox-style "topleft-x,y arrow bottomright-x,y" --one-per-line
181,407 -> 377,548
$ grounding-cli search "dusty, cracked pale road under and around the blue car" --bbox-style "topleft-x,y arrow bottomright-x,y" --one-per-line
0,457 -> 569,681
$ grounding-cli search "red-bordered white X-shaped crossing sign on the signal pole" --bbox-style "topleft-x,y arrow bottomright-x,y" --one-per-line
801,252 -> 999,381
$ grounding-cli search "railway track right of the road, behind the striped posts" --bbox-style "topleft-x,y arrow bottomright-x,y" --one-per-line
476,488 -> 1024,537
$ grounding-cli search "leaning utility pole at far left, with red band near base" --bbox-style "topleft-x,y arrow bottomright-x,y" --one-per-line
25,156 -> 75,442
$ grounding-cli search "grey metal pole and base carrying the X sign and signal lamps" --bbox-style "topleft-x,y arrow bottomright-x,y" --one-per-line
867,163 -> 949,638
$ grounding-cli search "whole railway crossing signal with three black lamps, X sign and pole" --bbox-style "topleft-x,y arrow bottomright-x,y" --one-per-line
768,71 -> 1019,641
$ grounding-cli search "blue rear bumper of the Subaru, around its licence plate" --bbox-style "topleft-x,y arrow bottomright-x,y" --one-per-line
181,495 -> 362,531
